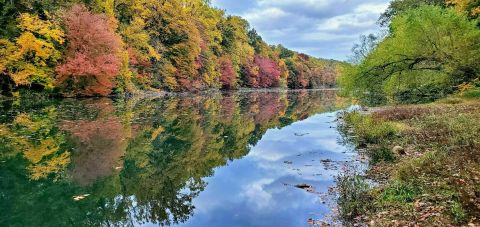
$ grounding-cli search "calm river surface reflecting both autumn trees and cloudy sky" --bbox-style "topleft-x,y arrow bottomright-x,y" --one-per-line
0,91 -> 354,227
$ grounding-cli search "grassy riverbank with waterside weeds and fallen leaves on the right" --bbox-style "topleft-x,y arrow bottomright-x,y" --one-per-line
337,97 -> 480,226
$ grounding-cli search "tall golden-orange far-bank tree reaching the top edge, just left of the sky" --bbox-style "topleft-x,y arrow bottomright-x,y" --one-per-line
144,0 -> 201,91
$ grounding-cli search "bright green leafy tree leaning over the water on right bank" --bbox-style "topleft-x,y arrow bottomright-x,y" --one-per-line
343,5 -> 480,102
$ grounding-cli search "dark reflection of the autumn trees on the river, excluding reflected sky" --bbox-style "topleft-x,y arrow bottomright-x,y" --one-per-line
0,91 -> 335,226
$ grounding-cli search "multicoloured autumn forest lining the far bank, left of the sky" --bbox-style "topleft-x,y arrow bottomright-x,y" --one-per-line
0,0 -> 343,97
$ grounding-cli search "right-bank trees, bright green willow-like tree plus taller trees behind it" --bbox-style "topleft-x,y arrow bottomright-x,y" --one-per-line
340,0 -> 480,104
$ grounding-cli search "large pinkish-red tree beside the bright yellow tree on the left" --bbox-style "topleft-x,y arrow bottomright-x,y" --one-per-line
57,5 -> 121,96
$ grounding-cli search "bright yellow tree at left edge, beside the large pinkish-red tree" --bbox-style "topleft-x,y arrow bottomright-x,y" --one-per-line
0,13 -> 64,90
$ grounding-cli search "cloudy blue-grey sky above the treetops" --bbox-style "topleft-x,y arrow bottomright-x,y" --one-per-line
212,0 -> 390,60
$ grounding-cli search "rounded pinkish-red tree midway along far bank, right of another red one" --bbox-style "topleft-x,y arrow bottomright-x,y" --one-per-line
254,55 -> 282,88
